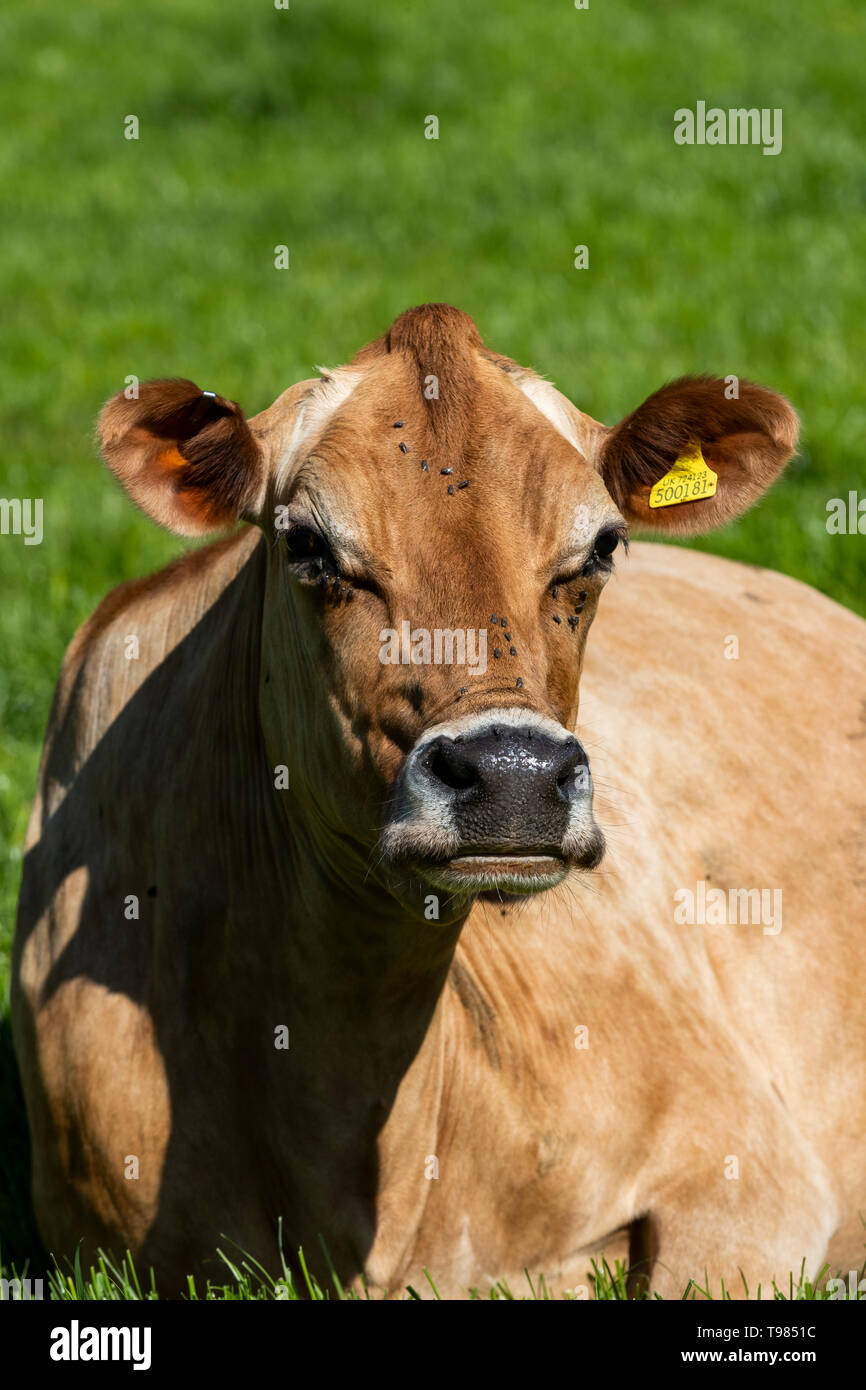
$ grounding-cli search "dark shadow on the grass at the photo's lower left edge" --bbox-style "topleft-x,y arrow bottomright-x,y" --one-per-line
0,1012 -> 47,1270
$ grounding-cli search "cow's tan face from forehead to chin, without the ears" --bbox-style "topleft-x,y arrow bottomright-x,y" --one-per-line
250,336 -> 626,892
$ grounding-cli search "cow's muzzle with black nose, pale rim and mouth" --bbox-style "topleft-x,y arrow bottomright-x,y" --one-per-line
382,710 -> 605,894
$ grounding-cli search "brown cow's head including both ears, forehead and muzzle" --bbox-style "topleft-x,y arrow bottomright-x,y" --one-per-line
100,304 -> 796,899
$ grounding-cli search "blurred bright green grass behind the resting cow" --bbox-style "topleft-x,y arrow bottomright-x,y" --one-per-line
0,0 -> 866,1261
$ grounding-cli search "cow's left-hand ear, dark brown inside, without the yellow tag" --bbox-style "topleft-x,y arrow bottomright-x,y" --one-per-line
99,379 -> 264,535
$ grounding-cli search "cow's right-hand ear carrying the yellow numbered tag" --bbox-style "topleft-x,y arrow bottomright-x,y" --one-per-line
595,377 -> 798,535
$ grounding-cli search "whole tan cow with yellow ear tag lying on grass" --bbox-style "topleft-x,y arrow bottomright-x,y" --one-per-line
13,304 -> 866,1298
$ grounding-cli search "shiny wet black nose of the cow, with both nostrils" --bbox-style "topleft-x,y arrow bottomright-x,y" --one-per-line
417,727 -> 591,852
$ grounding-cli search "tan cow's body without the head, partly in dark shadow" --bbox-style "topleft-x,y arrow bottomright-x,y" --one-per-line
14,304 -> 866,1297
